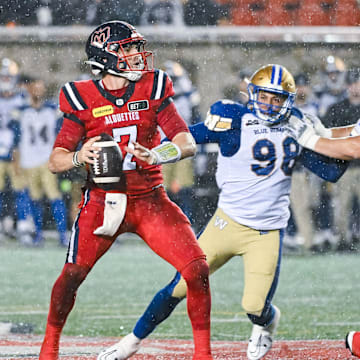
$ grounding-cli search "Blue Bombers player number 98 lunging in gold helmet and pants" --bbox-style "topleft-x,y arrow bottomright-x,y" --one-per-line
98,65 -> 346,360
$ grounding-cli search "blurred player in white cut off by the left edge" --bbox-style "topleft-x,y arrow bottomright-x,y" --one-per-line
0,58 -> 31,243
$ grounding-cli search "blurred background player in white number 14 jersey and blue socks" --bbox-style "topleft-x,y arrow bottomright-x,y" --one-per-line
17,78 -> 67,246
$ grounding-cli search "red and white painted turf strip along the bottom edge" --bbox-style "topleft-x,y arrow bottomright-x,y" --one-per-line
0,334 -> 355,360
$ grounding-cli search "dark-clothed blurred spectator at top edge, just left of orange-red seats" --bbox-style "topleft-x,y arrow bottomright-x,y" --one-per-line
183,0 -> 228,26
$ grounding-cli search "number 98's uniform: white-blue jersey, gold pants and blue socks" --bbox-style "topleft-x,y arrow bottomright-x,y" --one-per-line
128,100 -> 347,339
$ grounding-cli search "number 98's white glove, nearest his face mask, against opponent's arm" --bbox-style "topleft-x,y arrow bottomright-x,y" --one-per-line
286,116 -> 320,150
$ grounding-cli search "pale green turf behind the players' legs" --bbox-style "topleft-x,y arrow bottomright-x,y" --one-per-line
0,238 -> 360,341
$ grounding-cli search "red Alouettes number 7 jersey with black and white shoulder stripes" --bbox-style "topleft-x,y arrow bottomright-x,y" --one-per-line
54,69 -> 189,194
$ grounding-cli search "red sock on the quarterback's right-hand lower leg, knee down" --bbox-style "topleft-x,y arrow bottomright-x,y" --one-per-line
181,259 -> 212,360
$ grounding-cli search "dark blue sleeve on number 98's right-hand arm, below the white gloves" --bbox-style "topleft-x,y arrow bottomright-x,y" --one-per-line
299,149 -> 349,182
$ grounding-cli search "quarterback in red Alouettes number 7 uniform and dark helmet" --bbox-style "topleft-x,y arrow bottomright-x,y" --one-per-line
39,21 -> 212,360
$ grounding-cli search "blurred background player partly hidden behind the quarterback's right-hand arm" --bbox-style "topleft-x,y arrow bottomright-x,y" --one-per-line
163,60 -> 200,224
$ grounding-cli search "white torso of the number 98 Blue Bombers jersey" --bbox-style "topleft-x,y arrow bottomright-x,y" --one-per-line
216,104 -> 300,230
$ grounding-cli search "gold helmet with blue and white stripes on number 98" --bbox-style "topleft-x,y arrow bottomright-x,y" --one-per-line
248,64 -> 296,125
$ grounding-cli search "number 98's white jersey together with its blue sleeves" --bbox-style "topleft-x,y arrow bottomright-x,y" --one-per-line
190,100 -> 346,230
